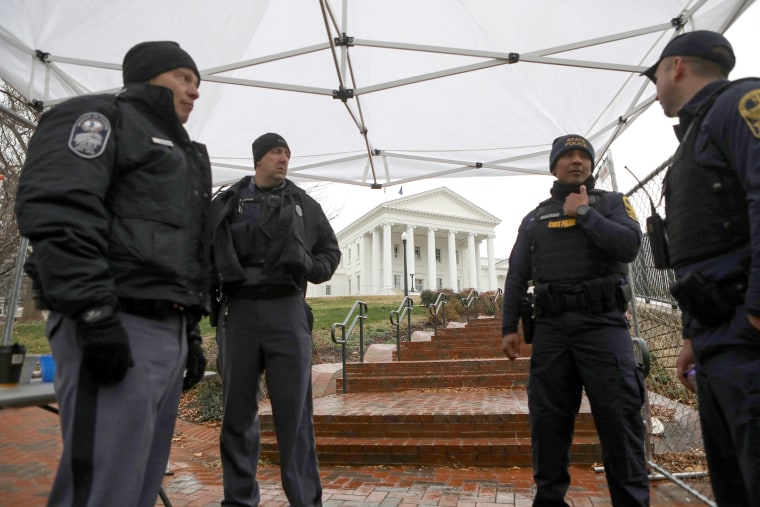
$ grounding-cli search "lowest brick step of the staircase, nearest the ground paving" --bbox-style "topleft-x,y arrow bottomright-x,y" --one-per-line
261,436 -> 602,467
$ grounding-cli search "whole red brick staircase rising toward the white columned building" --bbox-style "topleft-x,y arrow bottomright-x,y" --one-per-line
260,319 -> 601,467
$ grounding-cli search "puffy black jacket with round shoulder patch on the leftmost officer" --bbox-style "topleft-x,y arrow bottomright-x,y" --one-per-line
16,83 -> 217,316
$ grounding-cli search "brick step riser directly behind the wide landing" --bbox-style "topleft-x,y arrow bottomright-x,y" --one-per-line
335,372 -> 528,393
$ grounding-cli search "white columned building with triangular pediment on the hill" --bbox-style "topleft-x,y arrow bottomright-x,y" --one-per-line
307,187 -> 507,296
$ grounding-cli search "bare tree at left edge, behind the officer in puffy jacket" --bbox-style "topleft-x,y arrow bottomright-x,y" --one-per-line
0,79 -> 40,320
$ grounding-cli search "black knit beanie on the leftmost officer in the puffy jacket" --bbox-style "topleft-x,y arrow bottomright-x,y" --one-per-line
121,41 -> 201,85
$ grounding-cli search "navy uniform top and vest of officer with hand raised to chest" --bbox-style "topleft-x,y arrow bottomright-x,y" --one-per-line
502,177 -> 642,336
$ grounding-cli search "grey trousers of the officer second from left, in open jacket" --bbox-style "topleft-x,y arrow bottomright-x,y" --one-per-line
216,295 -> 322,507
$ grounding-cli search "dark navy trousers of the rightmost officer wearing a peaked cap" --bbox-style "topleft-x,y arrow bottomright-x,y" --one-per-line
692,307 -> 760,507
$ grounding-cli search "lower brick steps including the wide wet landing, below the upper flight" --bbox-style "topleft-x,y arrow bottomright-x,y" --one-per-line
259,389 -> 601,467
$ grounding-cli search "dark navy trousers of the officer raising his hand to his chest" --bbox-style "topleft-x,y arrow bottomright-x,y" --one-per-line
528,311 -> 649,507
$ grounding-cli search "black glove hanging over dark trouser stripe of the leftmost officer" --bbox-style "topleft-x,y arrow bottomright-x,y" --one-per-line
77,307 -> 134,385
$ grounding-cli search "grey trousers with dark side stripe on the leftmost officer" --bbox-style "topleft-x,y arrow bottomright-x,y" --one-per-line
47,312 -> 187,507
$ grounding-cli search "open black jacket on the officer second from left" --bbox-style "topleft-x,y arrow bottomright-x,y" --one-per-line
212,176 -> 341,292
